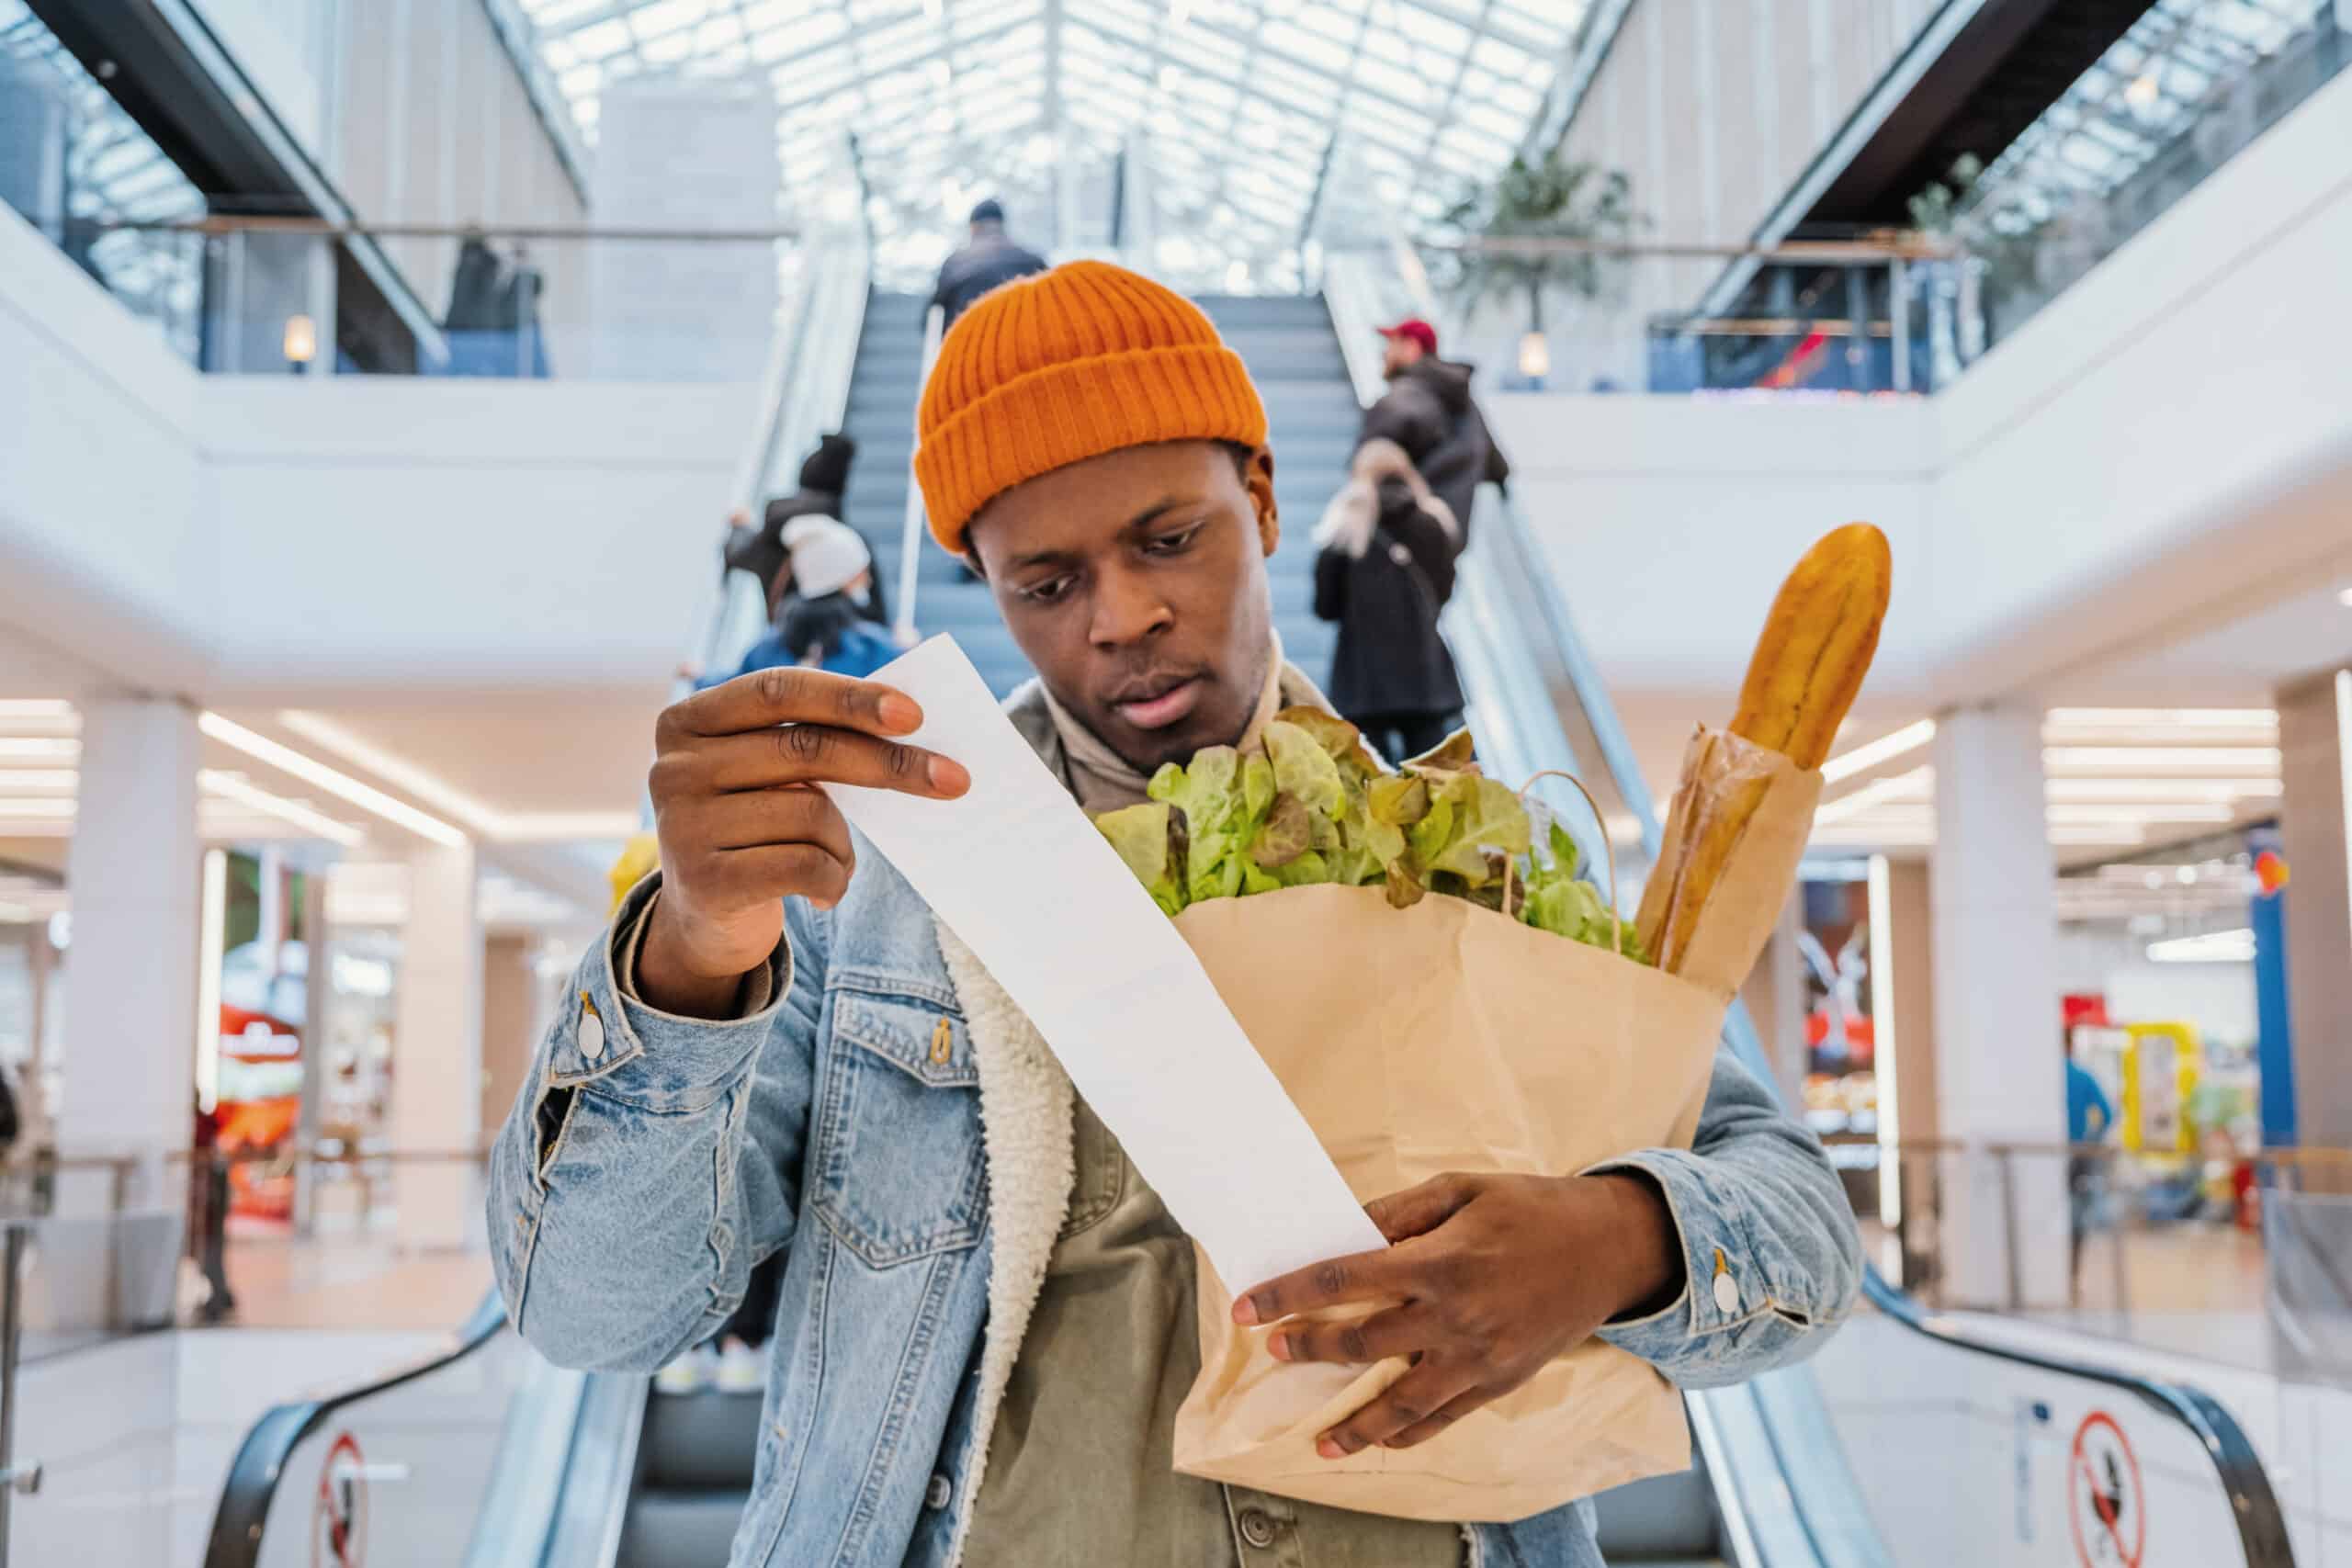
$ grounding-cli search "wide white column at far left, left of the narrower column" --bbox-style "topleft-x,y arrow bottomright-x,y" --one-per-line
56,698 -> 202,1206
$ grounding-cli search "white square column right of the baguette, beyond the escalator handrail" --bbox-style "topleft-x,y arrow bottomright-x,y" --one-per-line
1928,703 -> 2067,1307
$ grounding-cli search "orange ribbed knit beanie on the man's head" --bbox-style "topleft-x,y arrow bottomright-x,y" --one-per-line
915,261 -> 1265,555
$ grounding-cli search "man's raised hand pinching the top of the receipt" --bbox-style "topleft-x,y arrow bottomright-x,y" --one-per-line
638,668 -> 971,1018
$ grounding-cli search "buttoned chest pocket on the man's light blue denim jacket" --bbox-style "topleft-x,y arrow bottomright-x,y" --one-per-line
809,980 -> 988,1267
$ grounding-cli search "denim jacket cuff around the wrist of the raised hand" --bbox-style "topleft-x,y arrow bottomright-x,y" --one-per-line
548,872 -> 793,1110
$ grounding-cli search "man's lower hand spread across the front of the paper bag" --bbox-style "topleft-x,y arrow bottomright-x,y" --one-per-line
1232,1173 -> 1681,1460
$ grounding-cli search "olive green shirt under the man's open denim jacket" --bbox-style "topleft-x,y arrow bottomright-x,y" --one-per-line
962,1100 -> 1463,1568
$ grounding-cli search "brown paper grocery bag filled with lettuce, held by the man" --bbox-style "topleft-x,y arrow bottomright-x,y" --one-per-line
1170,742 -> 1818,1521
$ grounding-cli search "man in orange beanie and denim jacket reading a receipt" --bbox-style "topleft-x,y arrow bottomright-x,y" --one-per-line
489,264 -> 1860,1568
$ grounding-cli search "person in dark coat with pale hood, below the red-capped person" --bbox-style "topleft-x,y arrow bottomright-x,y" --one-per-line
1315,440 -> 1463,761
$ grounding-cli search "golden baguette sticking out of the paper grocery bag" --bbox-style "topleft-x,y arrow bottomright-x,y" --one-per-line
1639,522 -> 1894,974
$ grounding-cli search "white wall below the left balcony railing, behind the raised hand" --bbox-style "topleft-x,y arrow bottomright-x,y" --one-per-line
200,376 -> 755,701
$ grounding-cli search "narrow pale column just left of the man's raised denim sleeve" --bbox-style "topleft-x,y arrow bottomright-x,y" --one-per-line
393,844 -> 482,1248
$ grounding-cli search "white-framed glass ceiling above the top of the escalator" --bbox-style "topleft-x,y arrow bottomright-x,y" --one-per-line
520,0 -> 1592,285
